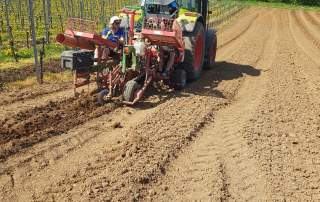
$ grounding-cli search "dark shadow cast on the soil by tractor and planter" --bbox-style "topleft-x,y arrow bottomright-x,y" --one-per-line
135,61 -> 261,109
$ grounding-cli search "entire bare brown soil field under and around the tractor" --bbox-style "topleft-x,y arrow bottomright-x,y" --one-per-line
0,8 -> 320,201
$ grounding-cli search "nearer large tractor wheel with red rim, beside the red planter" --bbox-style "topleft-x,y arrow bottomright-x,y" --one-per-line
182,21 -> 205,81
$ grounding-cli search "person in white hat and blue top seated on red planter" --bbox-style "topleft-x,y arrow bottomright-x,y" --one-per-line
94,16 -> 125,65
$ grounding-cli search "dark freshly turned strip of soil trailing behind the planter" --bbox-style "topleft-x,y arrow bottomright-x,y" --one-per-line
0,96 -> 116,161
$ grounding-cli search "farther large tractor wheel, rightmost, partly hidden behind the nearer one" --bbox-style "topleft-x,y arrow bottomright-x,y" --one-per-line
204,29 -> 217,69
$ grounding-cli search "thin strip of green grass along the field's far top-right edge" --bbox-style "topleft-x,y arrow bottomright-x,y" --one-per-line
241,0 -> 320,11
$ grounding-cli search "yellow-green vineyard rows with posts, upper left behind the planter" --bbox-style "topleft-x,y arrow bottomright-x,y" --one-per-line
0,0 -> 139,47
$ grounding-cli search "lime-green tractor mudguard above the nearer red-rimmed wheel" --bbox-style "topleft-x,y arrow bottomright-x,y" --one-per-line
177,8 -> 203,32
